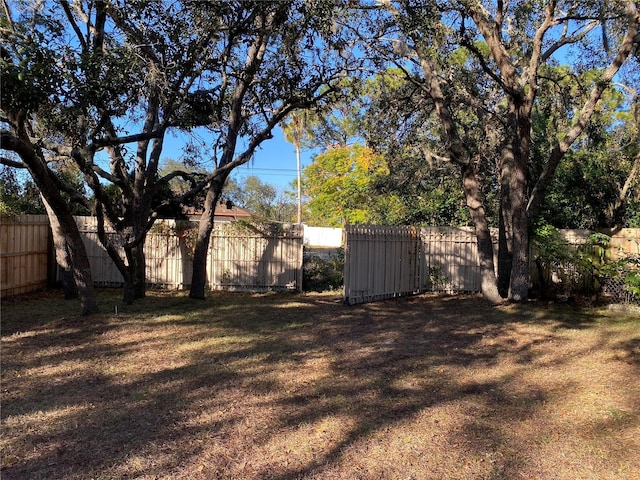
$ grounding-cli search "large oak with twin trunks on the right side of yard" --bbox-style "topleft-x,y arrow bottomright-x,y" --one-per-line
366,0 -> 640,301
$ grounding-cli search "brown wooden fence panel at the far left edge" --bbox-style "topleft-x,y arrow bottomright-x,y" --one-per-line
0,215 -> 51,297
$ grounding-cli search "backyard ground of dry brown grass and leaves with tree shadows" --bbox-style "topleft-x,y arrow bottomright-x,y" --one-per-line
0,291 -> 640,480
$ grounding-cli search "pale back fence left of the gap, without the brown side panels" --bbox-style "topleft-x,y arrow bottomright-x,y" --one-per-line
76,217 -> 303,291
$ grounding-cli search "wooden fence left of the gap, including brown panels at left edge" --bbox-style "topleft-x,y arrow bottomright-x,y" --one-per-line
0,215 -> 303,297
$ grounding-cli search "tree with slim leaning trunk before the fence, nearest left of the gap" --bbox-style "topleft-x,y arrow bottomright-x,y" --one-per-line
189,0 -> 360,298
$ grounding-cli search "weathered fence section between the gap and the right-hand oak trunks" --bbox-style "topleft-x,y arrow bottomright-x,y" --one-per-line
344,226 -> 481,304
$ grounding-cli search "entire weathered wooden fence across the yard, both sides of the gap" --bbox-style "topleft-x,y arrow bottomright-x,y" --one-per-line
5,215 -> 640,304
